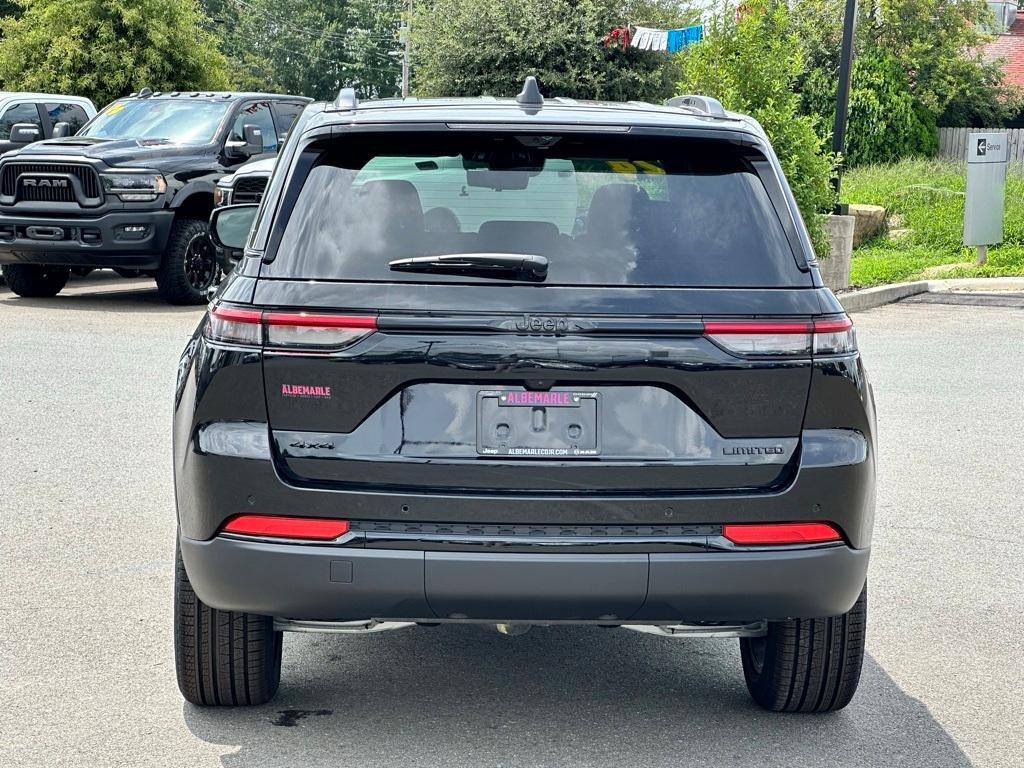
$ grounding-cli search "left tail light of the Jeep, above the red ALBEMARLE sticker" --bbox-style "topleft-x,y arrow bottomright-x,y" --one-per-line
206,305 -> 377,352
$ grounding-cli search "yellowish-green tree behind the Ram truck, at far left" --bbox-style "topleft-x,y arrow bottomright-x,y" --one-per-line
0,0 -> 229,105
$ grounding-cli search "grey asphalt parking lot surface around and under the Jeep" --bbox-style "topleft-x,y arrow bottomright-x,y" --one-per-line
0,272 -> 1024,768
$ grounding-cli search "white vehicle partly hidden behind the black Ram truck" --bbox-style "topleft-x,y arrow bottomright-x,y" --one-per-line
0,91 -> 96,155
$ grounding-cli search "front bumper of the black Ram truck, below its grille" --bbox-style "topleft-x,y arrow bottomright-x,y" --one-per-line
0,210 -> 174,269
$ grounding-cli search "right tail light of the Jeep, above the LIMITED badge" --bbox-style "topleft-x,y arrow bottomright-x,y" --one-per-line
703,316 -> 857,356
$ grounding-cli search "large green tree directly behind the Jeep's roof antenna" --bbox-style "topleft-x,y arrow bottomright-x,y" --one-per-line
412,0 -> 696,100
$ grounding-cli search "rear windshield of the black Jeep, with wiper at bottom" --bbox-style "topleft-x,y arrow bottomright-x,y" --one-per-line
261,132 -> 809,287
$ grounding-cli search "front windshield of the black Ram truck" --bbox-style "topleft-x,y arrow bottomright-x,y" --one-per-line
81,97 -> 228,144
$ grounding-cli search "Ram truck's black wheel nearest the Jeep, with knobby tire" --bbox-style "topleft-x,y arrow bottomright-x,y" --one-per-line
157,218 -> 219,304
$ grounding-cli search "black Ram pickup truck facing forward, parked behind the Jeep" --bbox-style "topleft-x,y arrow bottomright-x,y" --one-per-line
0,89 -> 309,304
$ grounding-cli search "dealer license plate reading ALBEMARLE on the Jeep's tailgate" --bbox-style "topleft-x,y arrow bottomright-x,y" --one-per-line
476,389 -> 601,459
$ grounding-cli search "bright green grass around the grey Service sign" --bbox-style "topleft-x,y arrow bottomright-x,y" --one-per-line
843,160 -> 1024,287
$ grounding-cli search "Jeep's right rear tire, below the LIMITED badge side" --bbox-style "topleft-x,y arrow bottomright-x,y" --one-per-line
739,584 -> 867,713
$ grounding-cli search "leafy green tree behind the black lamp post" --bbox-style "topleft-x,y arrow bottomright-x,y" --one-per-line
792,0 -> 1020,165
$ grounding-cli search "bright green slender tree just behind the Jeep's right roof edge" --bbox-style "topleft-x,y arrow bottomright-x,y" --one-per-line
679,0 -> 836,250
